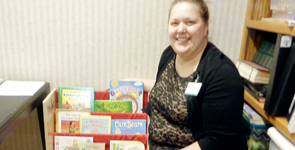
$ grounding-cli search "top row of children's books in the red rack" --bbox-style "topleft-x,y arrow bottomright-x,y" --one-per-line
58,81 -> 144,113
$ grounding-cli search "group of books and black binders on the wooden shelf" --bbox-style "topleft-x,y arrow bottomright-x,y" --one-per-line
236,34 -> 295,116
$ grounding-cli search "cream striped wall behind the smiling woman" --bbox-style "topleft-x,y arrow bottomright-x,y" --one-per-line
0,0 -> 247,90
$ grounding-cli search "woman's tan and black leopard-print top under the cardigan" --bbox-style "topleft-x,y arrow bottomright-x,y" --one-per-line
149,56 -> 197,150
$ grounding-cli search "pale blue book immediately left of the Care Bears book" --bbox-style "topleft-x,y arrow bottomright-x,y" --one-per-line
80,115 -> 112,134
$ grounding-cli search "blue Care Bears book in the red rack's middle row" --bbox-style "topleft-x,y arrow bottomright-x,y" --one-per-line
111,119 -> 146,135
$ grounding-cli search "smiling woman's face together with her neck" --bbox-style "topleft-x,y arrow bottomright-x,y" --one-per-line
168,1 -> 208,77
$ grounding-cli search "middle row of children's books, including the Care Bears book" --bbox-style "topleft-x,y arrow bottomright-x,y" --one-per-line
56,109 -> 147,135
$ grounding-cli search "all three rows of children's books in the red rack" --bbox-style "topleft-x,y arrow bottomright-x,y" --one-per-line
54,81 -> 147,150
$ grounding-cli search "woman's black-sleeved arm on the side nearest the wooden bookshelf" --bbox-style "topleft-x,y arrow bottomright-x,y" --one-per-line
198,63 -> 246,150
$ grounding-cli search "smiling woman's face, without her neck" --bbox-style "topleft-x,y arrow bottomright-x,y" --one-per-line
168,2 -> 208,56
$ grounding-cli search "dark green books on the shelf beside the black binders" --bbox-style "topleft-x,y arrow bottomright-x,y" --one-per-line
252,41 -> 275,69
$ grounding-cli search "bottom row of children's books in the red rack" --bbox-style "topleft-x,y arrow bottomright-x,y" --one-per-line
54,136 -> 145,150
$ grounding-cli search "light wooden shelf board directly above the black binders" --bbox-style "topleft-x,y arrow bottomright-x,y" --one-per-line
245,20 -> 295,36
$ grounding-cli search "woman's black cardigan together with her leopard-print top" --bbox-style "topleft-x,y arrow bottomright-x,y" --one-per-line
143,42 -> 247,150
